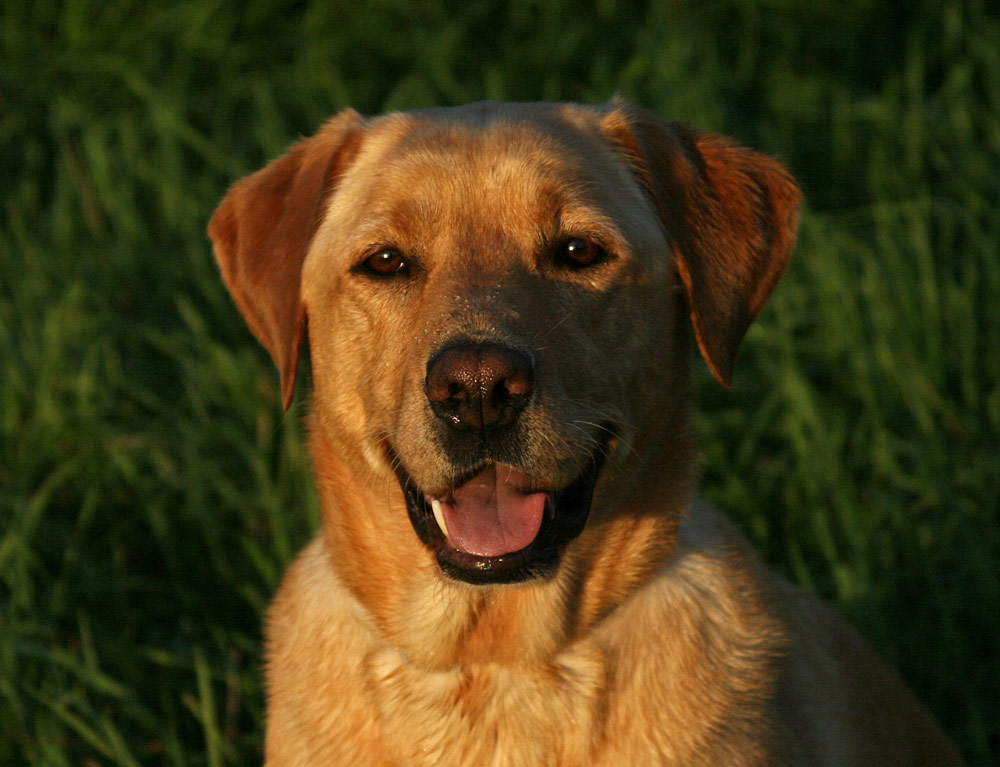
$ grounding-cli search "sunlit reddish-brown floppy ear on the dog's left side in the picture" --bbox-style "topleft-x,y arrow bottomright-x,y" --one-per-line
208,109 -> 363,410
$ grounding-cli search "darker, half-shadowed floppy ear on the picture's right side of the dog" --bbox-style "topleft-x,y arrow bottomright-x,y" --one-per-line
603,101 -> 802,386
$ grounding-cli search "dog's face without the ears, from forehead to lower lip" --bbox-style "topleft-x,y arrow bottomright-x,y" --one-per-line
303,105 -> 676,583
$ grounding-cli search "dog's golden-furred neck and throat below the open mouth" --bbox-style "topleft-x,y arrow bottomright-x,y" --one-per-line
311,404 -> 693,669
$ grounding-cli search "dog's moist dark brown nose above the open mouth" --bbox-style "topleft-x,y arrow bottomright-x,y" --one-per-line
424,343 -> 535,431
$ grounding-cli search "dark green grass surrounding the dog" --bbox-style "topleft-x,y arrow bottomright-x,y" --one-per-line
0,0 -> 1000,767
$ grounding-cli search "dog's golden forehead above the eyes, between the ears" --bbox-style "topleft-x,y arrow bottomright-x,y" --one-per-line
324,104 -> 658,262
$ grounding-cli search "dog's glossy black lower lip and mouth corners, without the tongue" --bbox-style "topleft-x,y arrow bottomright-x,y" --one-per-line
386,444 -> 607,585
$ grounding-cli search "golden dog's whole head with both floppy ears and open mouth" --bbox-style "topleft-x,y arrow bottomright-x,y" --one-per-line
209,97 -> 799,584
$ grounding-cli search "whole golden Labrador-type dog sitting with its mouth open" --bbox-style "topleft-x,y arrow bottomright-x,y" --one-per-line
209,99 -> 961,767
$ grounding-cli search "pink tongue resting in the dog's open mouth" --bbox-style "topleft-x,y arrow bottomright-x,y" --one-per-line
441,464 -> 546,557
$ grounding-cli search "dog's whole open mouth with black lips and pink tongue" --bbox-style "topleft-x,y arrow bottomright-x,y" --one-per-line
387,445 -> 606,586
